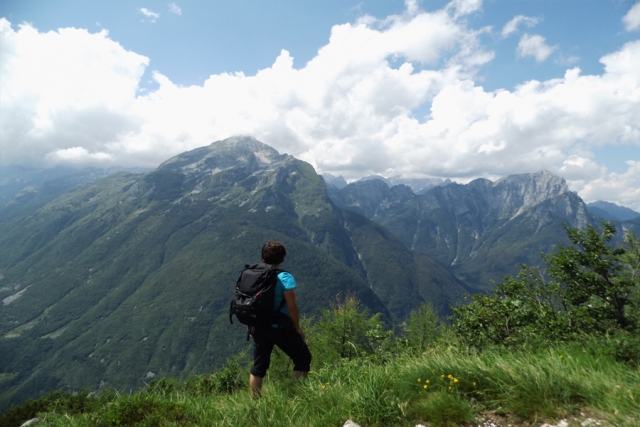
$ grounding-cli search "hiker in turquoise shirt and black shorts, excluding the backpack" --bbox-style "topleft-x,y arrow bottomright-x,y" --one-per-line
249,240 -> 311,397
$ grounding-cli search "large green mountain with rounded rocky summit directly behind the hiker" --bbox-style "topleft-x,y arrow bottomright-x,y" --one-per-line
0,137 -> 474,408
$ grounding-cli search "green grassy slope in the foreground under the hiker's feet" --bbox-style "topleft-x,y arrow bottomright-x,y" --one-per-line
5,346 -> 640,427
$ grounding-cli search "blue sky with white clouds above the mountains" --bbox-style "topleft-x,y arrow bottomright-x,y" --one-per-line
0,0 -> 640,211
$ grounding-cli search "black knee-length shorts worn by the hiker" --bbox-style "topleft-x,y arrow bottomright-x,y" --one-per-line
251,327 -> 311,378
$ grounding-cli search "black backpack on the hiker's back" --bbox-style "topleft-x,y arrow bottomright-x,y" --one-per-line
229,263 -> 284,327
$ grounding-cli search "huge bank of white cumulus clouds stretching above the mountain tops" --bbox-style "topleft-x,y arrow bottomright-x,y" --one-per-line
0,1 -> 640,210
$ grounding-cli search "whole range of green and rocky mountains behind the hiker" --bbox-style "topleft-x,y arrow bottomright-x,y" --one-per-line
0,137 -> 640,409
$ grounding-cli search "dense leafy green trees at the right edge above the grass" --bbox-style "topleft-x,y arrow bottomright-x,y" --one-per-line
451,223 -> 640,348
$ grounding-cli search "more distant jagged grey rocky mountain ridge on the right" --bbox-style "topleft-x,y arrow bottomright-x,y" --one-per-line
328,171 -> 636,289
